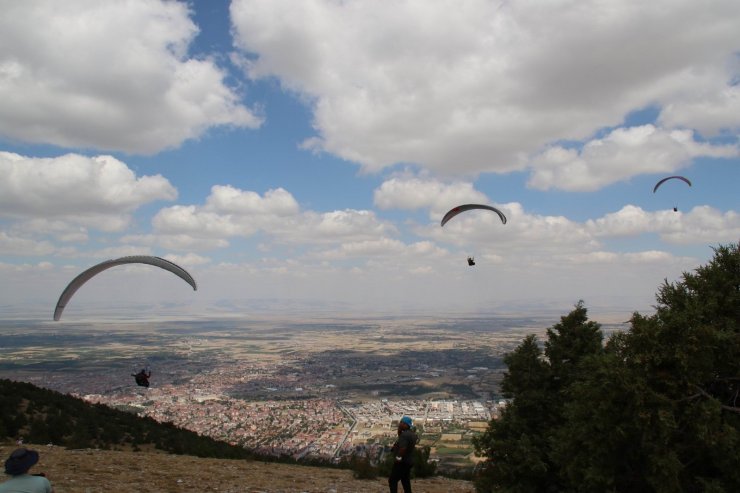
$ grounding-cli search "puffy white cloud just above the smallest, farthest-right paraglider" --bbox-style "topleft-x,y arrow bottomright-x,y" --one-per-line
528,125 -> 740,191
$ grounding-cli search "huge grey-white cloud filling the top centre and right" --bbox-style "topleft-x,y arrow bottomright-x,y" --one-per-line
231,0 -> 740,176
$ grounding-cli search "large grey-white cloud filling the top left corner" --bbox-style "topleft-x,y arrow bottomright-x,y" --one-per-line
0,0 -> 261,153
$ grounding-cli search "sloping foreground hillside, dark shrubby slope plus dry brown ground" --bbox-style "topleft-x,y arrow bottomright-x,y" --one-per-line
0,379 -> 474,493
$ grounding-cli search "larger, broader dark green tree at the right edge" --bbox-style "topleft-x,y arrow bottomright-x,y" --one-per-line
555,245 -> 740,492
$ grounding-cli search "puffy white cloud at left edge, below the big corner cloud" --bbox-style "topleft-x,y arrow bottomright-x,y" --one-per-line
0,152 -> 177,231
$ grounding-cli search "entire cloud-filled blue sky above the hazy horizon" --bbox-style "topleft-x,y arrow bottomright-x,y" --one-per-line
0,0 -> 740,318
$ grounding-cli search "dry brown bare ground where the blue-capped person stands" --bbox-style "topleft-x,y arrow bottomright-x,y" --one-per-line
0,443 -> 475,493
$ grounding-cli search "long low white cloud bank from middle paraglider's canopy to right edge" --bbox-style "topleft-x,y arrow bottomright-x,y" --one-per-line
404,179 -> 740,263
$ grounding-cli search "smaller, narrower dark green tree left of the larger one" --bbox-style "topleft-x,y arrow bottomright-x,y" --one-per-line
474,301 -> 603,493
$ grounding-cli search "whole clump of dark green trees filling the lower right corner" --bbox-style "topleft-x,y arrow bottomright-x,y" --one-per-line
476,245 -> 740,493
